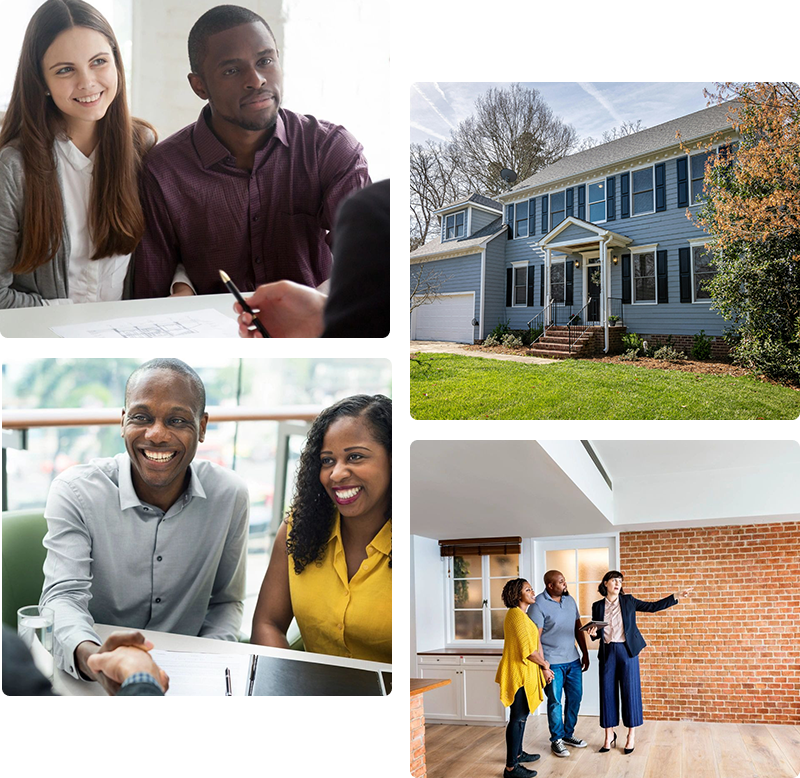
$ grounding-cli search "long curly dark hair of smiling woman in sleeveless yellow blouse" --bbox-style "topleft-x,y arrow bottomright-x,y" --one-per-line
286,394 -> 392,575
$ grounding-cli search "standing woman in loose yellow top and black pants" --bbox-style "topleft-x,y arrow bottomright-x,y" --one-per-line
495,578 -> 553,778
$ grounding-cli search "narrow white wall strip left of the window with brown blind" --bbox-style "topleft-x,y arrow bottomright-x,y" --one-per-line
410,535 -> 445,674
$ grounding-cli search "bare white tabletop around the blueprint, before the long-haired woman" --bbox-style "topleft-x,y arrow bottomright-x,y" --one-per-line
0,294 -> 238,339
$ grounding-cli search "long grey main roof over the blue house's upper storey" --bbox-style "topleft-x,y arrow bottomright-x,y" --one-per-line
500,100 -> 737,199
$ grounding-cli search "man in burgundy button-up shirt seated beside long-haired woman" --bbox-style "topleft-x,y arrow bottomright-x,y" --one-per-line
131,6 -> 369,297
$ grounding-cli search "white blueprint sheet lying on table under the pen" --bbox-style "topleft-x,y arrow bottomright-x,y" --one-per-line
50,308 -> 239,338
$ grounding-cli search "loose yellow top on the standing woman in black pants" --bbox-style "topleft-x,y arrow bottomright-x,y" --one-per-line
494,608 -> 544,712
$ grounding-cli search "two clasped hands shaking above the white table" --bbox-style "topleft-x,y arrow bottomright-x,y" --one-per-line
75,630 -> 169,697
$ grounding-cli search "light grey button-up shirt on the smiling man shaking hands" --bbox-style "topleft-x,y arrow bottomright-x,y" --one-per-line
39,454 -> 250,678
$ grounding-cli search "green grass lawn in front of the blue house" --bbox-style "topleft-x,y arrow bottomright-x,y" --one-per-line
411,354 -> 800,421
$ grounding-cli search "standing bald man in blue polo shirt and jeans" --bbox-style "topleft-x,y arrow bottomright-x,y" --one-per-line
528,570 -> 589,756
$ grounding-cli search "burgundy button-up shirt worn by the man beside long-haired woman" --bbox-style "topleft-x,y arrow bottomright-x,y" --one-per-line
132,107 -> 370,297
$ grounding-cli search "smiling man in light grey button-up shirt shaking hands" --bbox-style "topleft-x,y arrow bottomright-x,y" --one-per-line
40,359 -> 250,692
